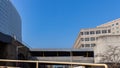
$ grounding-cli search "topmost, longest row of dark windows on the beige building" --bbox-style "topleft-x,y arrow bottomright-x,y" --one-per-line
81,29 -> 111,35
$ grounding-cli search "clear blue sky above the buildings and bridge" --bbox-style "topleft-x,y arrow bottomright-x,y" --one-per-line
11,0 -> 120,48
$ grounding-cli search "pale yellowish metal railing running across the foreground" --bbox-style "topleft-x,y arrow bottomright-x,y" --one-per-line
0,59 -> 108,68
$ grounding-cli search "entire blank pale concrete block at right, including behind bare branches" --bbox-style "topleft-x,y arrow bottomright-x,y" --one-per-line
94,35 -> 120,63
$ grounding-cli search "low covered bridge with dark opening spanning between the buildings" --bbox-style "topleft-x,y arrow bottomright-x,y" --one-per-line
30,48 -> 97,68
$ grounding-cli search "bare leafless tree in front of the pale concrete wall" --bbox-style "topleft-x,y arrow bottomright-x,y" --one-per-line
98,46 -> 120,68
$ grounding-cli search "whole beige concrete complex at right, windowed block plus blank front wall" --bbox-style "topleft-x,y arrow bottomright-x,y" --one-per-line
73,19 -> 120,63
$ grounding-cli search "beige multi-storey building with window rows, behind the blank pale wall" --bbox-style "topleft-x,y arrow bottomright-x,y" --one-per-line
73,19 -> 120,48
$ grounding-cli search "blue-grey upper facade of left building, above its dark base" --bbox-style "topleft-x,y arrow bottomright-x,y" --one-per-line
0,0 -> 22,42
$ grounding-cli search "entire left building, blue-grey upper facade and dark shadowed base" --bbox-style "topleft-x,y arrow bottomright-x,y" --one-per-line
0,0 -> 29,68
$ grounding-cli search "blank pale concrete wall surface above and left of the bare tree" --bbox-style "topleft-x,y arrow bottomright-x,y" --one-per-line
94,35 -> 120,63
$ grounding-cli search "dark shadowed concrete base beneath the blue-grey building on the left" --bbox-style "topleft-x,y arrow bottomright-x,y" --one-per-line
0,40 -> 30,66
